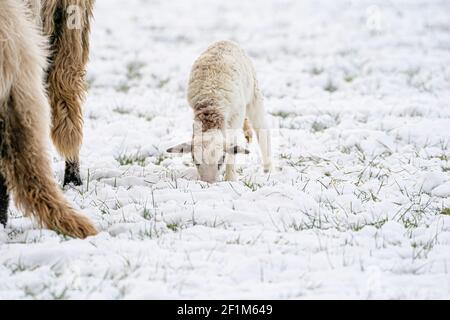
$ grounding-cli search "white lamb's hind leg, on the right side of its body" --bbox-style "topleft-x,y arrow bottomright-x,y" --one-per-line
247,92 -> 272,173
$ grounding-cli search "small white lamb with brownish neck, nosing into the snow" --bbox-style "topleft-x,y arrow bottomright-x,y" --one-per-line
167,41 -> 272,183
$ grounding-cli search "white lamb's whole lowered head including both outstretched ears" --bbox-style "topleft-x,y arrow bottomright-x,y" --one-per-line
167,129 -> 249,183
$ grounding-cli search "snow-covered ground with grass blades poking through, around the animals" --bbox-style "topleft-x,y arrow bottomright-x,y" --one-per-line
0,0 -> 450,299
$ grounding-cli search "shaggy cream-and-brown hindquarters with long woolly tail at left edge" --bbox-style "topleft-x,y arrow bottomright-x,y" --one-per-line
0,0 -> 97,238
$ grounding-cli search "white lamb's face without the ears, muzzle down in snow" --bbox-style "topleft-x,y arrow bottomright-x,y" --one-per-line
192,130 -> 227,183
